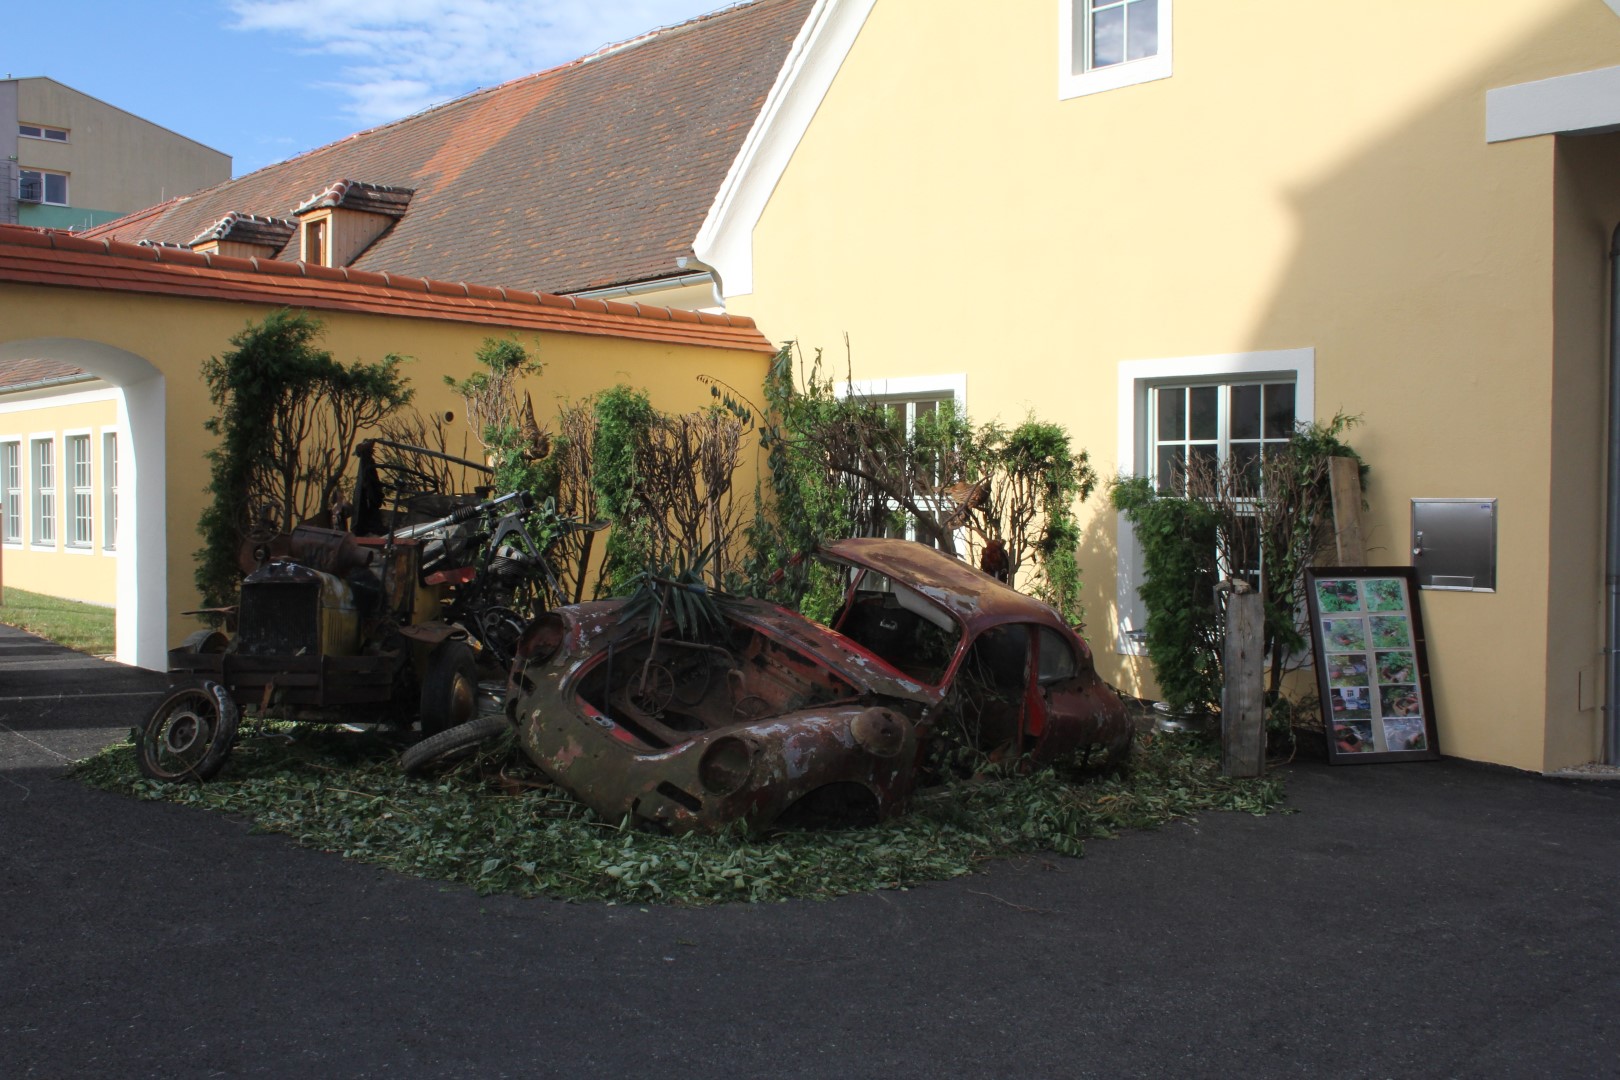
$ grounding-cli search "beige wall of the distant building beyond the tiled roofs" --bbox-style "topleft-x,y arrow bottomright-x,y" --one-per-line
16,78 -> 230,214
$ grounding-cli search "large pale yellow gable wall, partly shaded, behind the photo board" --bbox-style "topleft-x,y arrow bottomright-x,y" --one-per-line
729,0 -> 1620,769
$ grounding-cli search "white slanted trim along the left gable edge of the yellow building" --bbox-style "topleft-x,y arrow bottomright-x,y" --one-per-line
692,0 -> 876,298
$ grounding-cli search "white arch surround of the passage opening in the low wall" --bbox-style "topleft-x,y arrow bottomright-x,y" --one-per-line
0,337 -> 168,670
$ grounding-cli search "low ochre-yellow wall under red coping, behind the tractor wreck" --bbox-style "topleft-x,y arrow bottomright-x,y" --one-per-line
0,287 -> 768,654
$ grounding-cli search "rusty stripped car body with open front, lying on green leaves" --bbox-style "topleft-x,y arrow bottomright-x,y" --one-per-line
507,539 -> 1132,832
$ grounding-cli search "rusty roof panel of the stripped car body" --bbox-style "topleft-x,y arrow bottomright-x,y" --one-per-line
821,536 -> 1068,633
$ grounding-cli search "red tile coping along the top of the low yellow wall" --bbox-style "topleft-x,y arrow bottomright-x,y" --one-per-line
0,225 -> 774,353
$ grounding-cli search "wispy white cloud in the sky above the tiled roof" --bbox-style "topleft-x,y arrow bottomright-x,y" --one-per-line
228,0 -> 729,126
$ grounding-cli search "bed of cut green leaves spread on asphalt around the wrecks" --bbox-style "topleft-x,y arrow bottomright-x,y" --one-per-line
73,725 -> 1283,905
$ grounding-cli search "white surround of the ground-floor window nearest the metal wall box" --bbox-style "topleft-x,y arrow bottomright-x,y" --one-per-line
1115,348 -> 1315,656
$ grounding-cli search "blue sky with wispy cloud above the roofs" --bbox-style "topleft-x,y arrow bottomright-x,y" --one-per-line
0,0 -> 731,176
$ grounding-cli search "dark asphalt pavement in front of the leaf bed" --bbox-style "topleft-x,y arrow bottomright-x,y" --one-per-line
0,627 -> 1620,1080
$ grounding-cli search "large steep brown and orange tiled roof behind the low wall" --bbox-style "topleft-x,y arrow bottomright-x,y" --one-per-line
86,0 -> 813,293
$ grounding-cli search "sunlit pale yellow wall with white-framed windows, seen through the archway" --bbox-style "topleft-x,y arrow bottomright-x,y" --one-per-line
0,384 -> 118,607
